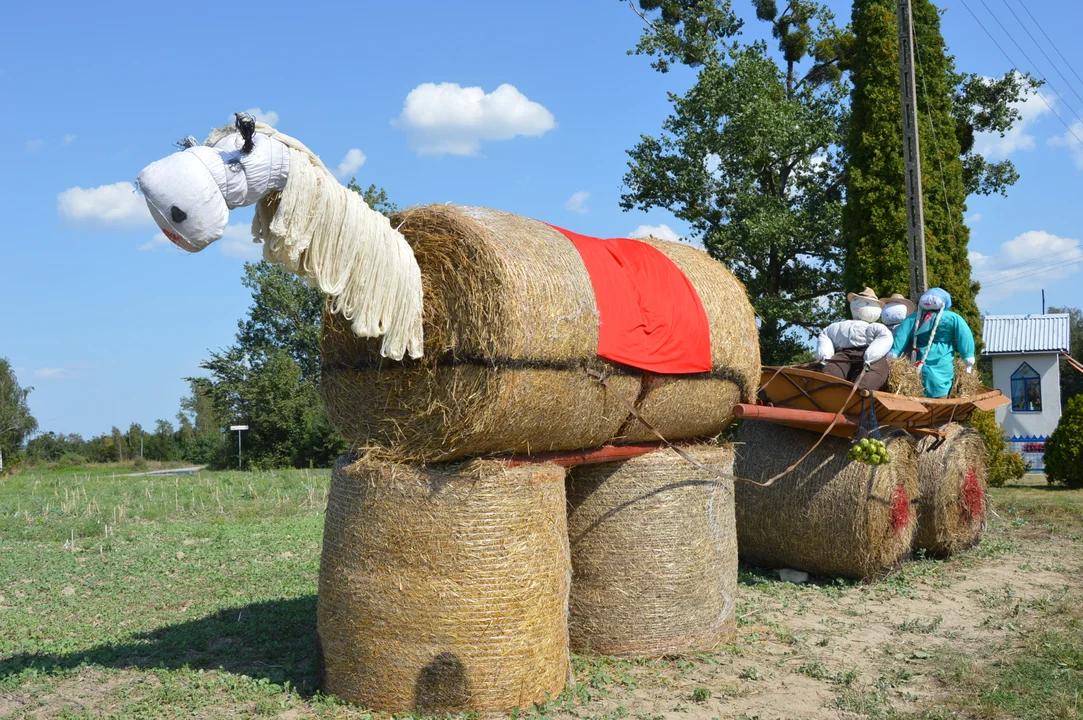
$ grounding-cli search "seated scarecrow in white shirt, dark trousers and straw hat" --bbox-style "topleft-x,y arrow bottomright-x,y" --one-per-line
815,288 -> 891,390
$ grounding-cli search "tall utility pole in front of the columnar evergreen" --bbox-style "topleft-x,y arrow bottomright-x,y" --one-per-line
898,0 -> 929,304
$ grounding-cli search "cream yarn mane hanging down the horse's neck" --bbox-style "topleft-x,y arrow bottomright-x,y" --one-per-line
205,122 -> 423,361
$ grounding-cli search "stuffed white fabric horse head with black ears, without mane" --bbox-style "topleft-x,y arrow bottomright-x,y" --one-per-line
135,113 -> 289,252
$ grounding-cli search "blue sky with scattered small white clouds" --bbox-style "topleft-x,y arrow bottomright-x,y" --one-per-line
0,0 -> 1083,436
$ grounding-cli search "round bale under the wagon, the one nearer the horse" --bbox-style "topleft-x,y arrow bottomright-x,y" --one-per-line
736,421 -> 918,579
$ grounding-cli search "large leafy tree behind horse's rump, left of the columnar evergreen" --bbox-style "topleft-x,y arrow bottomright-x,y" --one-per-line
621,0 -> 849,363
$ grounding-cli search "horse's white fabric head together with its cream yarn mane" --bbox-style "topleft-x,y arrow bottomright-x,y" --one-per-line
136,114 -> 423,361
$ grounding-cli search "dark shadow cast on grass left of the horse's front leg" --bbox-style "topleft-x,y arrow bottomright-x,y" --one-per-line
0,594 -> 319,696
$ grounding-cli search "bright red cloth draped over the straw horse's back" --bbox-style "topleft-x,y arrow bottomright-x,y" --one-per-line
551,225 -> 712,375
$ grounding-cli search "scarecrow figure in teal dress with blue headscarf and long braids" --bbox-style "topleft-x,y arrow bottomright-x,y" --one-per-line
888,288 -> 975,397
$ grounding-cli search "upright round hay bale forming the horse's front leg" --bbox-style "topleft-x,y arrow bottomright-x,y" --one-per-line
317,457 -> 571,714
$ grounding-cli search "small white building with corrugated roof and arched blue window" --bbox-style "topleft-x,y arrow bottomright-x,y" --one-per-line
981,314 -> 1071,470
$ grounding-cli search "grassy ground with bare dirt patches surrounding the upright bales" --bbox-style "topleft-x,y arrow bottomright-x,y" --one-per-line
0,468 -> 1083,720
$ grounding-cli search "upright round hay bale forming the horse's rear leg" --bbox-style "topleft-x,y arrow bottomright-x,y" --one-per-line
567,445 -> 738,657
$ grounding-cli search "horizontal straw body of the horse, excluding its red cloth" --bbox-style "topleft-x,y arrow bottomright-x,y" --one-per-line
321,206 -> 760,462
